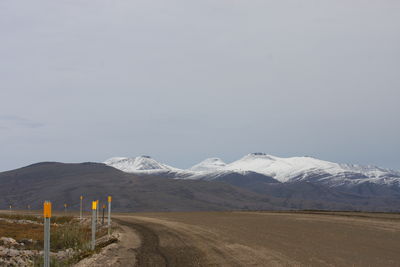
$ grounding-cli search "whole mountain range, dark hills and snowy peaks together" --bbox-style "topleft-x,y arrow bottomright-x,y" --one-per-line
0,153 -> 400,212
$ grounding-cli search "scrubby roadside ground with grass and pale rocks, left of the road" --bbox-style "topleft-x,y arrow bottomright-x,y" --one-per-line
0,214 -> 116,266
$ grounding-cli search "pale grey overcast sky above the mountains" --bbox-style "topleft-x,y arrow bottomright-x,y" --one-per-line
0,0 -> 400,171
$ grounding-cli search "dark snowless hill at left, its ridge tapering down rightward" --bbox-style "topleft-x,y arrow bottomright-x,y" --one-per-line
0,162 -> 280,211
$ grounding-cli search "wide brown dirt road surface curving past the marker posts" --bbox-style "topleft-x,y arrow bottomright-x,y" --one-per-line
104,212 -> 400,267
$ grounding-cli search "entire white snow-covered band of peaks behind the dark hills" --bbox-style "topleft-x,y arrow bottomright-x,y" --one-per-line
104,153 -> 400,187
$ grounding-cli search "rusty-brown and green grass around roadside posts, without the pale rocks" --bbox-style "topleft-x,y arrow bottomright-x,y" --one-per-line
0,214 -> 112,266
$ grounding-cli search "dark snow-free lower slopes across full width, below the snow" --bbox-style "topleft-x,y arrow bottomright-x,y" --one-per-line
0,162 -> 400,211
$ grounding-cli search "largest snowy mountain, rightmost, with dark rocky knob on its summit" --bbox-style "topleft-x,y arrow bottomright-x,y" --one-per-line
224,153 -> 400,185
